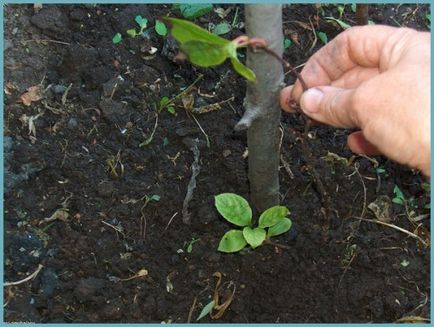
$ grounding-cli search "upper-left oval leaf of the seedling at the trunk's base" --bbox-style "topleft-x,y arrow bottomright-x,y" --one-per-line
215,193 -> 252,226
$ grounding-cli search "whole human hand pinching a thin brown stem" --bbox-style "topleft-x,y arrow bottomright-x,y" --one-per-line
280,25 -> 431,176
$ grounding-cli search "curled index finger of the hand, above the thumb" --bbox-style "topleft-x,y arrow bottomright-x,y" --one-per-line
292,25 -> 408,102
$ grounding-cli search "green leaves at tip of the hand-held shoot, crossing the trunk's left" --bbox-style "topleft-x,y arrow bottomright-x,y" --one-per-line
161,17 -> 256,81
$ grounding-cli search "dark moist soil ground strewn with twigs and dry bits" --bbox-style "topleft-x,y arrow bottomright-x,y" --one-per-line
4,4 -> 430,323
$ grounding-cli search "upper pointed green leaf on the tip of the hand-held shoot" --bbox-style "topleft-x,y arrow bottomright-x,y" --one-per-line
161,17 -> 230,46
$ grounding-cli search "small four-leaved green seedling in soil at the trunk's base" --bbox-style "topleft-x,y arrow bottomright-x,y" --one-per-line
215,193 -> 292,253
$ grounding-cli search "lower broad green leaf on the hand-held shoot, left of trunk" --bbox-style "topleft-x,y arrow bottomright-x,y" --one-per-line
181,41 -> 228,67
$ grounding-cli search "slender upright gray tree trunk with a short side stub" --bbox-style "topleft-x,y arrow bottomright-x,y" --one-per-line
235,4 -> 283,212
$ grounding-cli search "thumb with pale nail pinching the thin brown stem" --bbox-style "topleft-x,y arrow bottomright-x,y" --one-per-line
300,86 -> 361,128
